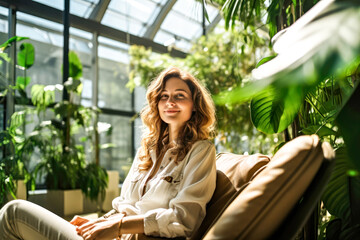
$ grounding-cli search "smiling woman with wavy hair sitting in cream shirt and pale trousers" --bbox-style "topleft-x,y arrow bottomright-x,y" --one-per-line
0,67 -> 216,239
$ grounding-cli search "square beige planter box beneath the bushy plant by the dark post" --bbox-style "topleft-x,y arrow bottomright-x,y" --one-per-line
46,189 -> 83,217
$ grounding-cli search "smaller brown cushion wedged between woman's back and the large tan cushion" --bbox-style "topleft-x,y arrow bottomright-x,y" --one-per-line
191,153 -> 270,240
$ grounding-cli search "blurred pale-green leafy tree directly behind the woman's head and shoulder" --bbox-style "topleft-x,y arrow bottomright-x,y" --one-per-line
127,25 -> 278,153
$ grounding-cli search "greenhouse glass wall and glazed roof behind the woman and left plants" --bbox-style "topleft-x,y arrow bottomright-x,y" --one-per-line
0,0 -> 219,187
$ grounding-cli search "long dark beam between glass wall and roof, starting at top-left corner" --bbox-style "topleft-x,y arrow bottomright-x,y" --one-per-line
0,0 -> 187,58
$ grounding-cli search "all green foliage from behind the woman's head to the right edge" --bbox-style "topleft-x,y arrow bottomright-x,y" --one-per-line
129,0 -> 360,239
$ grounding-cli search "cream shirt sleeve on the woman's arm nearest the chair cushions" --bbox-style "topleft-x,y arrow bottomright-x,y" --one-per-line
144,141 -> 216,238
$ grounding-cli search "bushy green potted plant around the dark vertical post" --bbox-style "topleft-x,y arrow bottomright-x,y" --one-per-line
28,52 -> 108,215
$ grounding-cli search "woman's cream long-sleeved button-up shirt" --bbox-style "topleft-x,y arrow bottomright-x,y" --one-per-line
112,140 -> 216,238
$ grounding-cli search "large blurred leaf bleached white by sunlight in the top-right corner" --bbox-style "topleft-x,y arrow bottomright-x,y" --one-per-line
253,0 -> 360,87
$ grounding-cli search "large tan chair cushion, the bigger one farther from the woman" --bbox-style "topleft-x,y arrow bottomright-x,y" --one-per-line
204,135 -> 324,240
